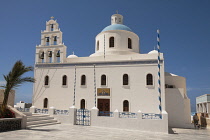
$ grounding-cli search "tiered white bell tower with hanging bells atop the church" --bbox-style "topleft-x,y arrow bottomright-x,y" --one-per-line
36,17 -> 66,63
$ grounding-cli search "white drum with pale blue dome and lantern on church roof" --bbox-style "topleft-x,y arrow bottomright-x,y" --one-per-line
90,14 -> 139,56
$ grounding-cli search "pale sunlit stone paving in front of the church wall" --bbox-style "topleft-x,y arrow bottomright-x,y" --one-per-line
0,124 -> 210,140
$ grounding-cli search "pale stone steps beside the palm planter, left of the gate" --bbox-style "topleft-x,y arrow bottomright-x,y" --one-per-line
26,114 -> 60,129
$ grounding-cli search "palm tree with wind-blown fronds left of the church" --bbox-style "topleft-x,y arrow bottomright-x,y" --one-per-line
0,60 -> 35,116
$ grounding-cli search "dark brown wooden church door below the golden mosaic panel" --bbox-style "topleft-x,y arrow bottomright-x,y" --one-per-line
98,99 -> 110,116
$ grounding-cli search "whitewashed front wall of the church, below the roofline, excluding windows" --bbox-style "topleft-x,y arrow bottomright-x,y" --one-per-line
33,59 -> 165,113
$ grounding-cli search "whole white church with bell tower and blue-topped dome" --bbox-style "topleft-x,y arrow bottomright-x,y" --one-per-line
32,14 -> 191,130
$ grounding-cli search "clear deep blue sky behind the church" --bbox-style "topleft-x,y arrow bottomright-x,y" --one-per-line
0,0 -> 210,111
